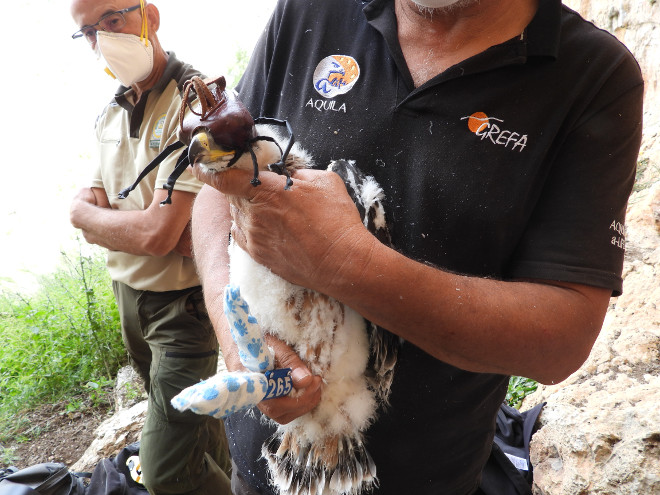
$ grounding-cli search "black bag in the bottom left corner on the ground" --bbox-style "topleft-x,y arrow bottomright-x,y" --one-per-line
0,462 -> 89,495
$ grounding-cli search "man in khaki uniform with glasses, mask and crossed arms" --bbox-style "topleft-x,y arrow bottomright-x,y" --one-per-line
71,0 -> 231,495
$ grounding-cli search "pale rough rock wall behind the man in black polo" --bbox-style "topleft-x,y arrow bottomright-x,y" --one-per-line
522,0 -> 660,495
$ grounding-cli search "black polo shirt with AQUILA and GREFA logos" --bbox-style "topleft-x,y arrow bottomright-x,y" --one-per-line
227,0 -> 643,495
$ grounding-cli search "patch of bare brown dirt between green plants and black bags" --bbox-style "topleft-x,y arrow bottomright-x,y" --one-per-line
0,403 -> 111,469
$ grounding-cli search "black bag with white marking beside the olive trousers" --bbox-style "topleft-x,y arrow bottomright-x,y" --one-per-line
85,442 -> 149,495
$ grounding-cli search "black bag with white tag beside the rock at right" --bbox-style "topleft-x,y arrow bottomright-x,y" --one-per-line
479,402 -> 545,495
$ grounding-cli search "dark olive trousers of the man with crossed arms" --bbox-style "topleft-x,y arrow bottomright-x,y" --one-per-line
113,282 -> 231,495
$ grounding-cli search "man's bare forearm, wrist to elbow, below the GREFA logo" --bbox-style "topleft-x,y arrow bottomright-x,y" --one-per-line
326,234 -> 610,383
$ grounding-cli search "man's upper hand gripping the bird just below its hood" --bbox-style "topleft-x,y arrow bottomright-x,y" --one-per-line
193,167 -> 378,294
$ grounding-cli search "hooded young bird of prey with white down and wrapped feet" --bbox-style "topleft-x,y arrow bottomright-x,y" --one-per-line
122,76 -> 400,495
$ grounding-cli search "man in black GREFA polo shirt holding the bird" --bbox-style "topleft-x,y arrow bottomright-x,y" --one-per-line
188,0 -> 643,495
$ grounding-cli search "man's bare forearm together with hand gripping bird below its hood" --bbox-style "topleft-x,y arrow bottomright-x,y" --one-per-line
191,170 -> 610,383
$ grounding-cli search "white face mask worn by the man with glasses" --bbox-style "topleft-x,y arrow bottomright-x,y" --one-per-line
96,31 -> 154,87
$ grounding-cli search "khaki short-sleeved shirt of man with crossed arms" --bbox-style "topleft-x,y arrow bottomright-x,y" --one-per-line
92,53 -> 202,292
